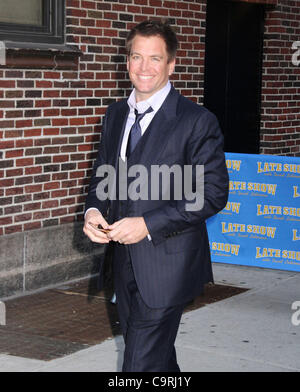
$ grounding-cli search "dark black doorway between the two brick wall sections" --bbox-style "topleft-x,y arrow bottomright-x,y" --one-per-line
204,0 -> 264,154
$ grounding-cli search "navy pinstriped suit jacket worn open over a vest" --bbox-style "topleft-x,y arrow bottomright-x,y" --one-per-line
86,87 -> 228,308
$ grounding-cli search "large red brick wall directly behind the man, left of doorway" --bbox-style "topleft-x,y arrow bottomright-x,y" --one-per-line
0,0 -> 206,235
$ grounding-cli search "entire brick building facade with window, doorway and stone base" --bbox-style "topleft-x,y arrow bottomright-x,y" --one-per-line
0,0 -> 300,297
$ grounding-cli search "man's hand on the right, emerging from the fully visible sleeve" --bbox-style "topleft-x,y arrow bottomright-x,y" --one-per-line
107,217 -> 149,245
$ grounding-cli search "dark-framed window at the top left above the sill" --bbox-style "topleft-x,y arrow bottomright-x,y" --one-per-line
0,0 -> 65,44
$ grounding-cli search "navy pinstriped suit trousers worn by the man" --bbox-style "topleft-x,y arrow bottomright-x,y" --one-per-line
114,244 -> 185,372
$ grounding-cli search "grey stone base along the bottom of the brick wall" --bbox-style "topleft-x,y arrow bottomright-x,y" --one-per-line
0,223 -> 105,298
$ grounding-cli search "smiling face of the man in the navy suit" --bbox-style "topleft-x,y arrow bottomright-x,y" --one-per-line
127,35 -> 175,102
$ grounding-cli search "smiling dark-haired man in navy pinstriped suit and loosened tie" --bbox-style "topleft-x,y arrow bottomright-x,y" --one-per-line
84,21 -> 228,372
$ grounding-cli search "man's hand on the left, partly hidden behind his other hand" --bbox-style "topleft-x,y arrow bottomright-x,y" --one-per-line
83,209 -> 110,244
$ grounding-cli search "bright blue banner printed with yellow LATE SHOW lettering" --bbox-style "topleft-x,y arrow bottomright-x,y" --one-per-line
207,153 -> 300,271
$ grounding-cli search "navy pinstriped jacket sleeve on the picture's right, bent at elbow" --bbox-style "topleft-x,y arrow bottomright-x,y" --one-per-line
143,110 -> 229,245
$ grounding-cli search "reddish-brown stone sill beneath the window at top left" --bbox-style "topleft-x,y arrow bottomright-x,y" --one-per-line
0,41 -> 82,70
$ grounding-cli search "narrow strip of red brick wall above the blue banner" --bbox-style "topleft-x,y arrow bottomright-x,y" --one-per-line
260,0 -> 300,156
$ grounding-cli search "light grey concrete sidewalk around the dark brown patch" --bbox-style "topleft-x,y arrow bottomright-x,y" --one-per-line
0,264 -> 300,372
